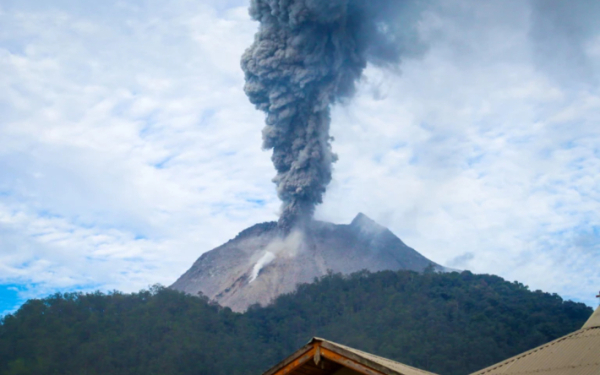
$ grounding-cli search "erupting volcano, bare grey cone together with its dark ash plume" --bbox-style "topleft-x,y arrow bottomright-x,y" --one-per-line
172,0 -> 444,311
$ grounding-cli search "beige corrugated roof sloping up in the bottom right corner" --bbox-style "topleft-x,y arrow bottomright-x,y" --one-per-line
472,308 -> 600,375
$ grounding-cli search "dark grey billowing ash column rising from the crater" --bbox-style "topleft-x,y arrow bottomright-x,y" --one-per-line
242,0 -> 423,231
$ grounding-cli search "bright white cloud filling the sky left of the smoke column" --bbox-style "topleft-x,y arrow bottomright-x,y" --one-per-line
0,2 -> 278,302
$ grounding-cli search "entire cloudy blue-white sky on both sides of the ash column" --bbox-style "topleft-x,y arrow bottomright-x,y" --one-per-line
0,0 -> 600,315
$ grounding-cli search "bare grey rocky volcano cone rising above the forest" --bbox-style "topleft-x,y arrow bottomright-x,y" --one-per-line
171,214 -> 445,311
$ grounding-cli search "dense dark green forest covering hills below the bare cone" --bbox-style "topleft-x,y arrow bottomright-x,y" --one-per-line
0,271 -> 592,375
